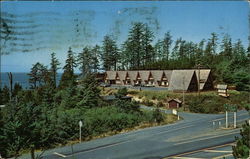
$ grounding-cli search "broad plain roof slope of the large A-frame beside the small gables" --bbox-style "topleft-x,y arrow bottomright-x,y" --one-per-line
169,70 -> 195,91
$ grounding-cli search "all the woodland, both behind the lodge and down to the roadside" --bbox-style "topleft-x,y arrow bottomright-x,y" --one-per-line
0,22 -> 250,159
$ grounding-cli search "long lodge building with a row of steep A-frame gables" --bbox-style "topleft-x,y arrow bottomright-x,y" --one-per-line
104,69 -> 213,92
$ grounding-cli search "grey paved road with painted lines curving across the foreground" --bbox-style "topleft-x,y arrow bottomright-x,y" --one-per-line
19,107 -> 249,159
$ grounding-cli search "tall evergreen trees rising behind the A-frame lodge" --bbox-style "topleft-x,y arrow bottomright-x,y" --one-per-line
54,22 -> 250,90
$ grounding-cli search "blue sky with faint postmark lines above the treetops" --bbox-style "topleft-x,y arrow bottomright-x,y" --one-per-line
0,1 -> 249,72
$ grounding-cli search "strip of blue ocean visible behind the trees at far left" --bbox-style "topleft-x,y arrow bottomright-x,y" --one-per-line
1,72 -> 62,89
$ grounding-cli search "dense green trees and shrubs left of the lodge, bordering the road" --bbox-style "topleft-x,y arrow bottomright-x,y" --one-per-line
0,45 -> 164,159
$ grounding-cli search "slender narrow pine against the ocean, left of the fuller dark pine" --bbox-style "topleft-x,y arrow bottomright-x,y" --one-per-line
50,52 -> 60,88
